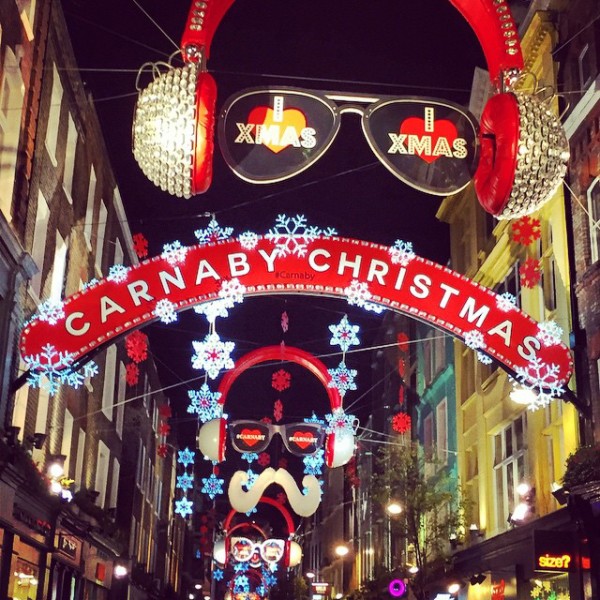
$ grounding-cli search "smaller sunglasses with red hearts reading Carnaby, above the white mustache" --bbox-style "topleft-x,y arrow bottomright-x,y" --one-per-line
228,420 -> 325,456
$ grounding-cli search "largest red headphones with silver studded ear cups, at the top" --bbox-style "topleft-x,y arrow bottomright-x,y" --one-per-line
134,0 -> 569,219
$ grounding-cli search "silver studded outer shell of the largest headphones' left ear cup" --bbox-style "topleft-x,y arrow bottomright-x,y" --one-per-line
133,63 -> 199,198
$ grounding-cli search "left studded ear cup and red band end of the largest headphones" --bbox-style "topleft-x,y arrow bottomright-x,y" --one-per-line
132,0 -> 233,198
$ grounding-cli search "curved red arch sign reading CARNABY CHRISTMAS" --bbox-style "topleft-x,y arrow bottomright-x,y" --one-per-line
20,237 -> 573,386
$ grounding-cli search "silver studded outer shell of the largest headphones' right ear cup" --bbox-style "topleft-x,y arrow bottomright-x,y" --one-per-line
496,92 -> 569,219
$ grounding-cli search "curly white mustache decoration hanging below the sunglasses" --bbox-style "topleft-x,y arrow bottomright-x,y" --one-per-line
227,467 -> 321,517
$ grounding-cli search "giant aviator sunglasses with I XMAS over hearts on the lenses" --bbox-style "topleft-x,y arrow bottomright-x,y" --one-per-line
218,87 -> 477,195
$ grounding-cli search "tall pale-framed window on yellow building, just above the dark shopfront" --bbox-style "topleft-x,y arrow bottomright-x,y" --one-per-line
493,414 -> 527,529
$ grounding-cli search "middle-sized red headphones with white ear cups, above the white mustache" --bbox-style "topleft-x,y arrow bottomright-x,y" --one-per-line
198,346 -> 355,468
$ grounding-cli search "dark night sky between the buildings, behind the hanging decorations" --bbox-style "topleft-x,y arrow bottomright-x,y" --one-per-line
63,0 -> 484,450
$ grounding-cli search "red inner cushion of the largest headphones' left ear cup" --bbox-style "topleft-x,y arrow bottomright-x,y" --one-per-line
192,71 -> 217,194
